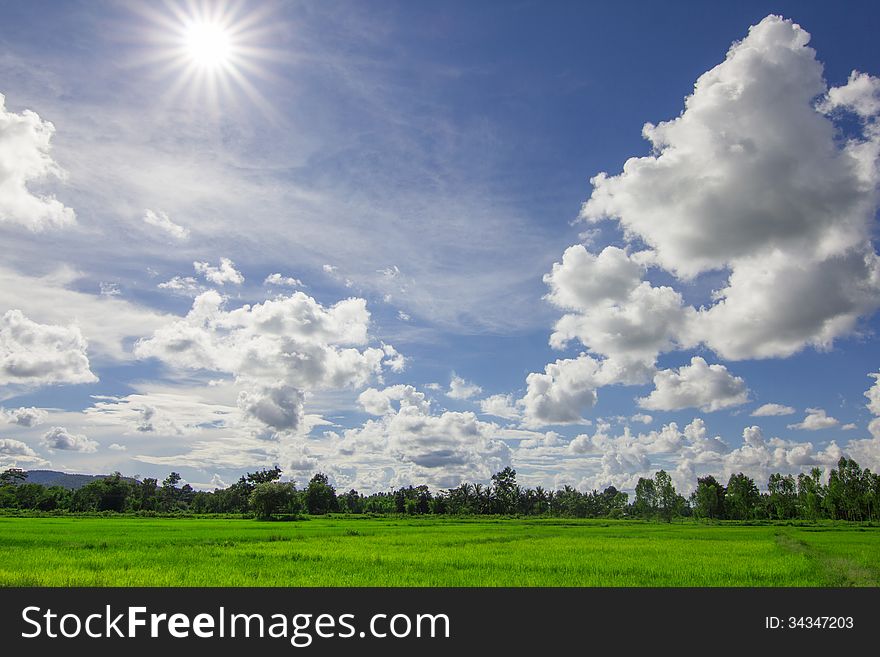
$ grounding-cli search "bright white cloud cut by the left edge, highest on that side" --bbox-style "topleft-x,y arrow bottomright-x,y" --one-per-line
0,94 -> 76,232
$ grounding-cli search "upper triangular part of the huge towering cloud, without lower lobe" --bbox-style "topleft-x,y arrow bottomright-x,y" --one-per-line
582,16 -> 873,277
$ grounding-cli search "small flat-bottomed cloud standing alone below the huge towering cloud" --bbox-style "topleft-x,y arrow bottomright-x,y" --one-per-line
639,356 -> 749,413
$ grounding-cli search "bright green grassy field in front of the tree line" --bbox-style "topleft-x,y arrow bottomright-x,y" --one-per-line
0,517 -> 880,587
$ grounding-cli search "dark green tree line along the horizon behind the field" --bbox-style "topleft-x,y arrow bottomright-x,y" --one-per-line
0,458 -> 880,522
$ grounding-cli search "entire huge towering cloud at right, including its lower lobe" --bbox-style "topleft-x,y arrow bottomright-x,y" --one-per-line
581,16 -> 880,359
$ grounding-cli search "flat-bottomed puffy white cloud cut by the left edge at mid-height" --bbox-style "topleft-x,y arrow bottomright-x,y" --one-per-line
0,310 -> 98,385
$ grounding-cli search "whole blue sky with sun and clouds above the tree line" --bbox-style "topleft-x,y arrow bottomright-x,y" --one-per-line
0,0 -> 880,490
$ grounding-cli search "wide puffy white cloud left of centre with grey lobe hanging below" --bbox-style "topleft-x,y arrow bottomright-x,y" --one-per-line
135,291 -> 404,431
